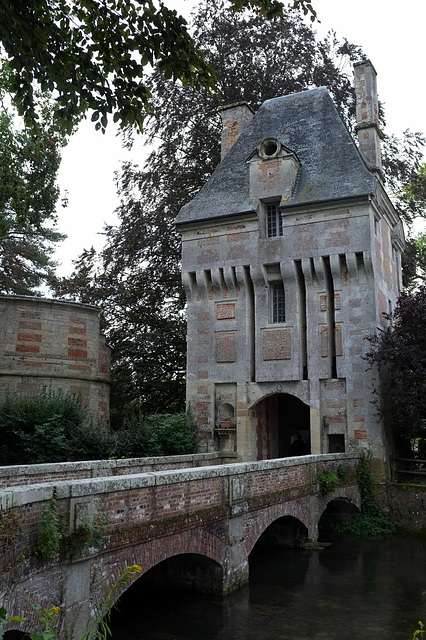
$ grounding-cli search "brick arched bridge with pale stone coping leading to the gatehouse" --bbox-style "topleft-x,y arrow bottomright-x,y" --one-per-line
0,454 -> 359,640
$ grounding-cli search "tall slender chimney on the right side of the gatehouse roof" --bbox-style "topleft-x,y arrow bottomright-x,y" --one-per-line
354,60 -> 383,181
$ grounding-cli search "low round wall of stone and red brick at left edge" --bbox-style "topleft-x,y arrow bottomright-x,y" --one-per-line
0,296 -> 110,420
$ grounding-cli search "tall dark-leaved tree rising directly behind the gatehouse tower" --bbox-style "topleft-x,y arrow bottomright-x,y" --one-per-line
56,0 -> 426,420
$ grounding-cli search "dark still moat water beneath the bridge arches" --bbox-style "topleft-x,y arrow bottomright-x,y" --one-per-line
112,536 -> 426,640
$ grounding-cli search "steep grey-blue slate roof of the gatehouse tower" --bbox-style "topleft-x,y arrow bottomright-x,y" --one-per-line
176,87 -> 376,224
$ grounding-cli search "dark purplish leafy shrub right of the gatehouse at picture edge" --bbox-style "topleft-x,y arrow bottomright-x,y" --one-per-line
367,285 -> 426,457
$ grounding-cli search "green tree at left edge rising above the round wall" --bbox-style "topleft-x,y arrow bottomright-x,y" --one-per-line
0,61 -> 64,294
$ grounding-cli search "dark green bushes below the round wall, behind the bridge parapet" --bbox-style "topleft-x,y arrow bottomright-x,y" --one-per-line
0,389 -> 196,465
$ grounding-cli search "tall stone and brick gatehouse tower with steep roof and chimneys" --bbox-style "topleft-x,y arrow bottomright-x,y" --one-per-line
176,61 -> 404,468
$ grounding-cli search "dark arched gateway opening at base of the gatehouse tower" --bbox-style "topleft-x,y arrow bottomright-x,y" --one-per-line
253,393 -> 311,460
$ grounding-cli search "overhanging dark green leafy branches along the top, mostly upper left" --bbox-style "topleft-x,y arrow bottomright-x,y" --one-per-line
0,0 -> 315,133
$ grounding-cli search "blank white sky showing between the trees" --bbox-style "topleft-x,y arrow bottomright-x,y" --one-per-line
56,0 -> 426,275
